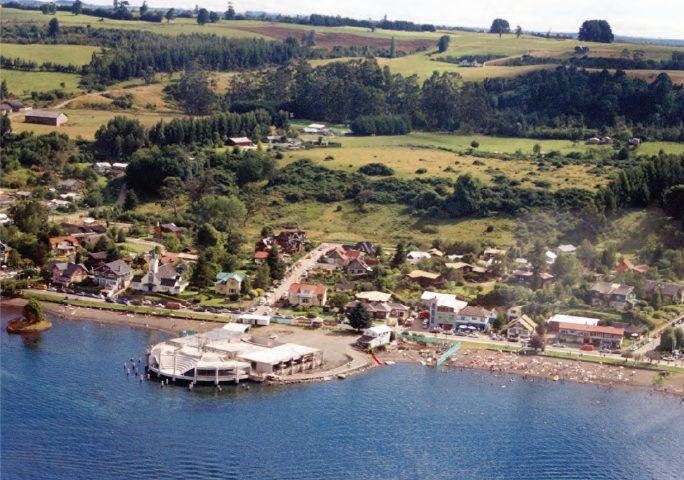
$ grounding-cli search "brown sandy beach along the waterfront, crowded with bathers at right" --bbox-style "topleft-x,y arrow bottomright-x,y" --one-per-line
2,298 -> 684,401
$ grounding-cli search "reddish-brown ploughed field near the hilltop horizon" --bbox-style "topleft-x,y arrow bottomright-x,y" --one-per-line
233,25 -> 435,52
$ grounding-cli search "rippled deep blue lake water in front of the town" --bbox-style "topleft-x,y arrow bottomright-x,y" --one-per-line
0,310 -> 684,480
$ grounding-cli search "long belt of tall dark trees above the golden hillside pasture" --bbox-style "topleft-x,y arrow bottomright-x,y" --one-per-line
227,59 -> 684,141
